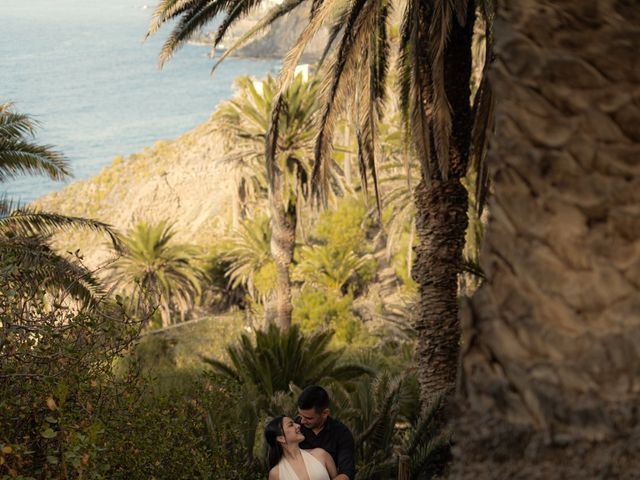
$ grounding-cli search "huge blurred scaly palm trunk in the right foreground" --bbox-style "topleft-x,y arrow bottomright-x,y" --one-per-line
452,0 -> 640,479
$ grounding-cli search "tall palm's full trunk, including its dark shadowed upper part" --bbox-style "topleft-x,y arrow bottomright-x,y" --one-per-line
412,1 -> 475,408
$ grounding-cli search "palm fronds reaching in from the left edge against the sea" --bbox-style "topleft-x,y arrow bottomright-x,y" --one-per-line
0,103 -> 119,306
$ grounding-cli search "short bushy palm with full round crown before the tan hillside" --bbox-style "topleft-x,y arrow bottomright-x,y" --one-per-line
108,221 -> 204,327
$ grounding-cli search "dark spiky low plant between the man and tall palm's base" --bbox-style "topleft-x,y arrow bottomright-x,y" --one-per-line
332,370 -> 451,480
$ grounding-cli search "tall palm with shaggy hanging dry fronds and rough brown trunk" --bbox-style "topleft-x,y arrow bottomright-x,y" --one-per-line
149,0 -> 492,407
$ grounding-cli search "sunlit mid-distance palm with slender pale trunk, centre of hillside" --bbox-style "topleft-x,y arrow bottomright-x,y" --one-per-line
216,75 -> 338,328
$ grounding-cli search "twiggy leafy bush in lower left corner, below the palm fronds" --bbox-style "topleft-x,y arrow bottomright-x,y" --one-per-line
0,264 -> 138,479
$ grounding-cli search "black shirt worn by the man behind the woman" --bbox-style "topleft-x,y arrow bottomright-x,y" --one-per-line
295,417 -> 356,480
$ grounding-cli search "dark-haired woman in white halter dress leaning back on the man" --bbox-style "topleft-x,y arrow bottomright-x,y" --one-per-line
264,416 -> 338,480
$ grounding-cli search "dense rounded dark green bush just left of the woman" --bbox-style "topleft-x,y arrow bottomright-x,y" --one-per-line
103,371 -> 257,480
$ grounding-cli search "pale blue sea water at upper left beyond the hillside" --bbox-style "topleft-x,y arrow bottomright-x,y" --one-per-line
0,0 -> 279,203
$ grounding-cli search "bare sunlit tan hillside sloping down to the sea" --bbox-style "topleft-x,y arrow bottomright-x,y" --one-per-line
34,116 -> 233,267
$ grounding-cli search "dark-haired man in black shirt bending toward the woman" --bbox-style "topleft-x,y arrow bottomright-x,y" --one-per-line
295,385 -> 356,480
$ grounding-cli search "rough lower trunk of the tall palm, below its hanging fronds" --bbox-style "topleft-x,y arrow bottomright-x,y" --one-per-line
412,179 -> 467,407
